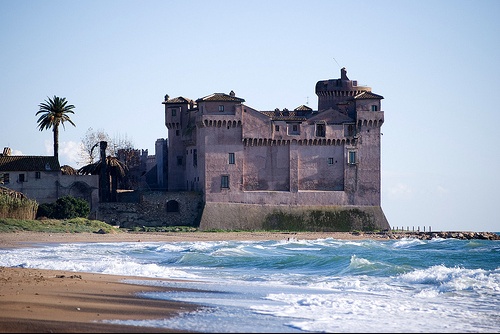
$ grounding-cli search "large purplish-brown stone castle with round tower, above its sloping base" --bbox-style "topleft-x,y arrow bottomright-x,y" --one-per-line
162,68 -> 389,229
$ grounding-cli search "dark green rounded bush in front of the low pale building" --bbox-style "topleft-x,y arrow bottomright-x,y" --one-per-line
37,195 -> 90,219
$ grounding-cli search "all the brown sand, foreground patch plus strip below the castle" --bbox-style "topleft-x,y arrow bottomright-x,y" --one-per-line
0,232 -> 376,333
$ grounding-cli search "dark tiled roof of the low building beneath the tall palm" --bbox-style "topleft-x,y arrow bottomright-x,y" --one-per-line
0,155 -> 61,172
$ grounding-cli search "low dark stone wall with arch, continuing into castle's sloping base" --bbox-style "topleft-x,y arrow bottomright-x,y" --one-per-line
94,191 -> 391,232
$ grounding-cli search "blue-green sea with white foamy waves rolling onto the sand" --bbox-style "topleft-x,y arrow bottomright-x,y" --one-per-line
0,234 -> 500,333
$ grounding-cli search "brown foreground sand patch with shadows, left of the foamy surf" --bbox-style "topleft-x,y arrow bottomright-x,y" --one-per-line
0,267 -> 198,333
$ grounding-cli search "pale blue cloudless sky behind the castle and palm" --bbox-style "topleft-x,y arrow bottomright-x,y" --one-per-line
0,0 -> 500,232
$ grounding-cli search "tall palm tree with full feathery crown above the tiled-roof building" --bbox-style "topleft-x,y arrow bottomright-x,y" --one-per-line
35,95 -> 76,158
